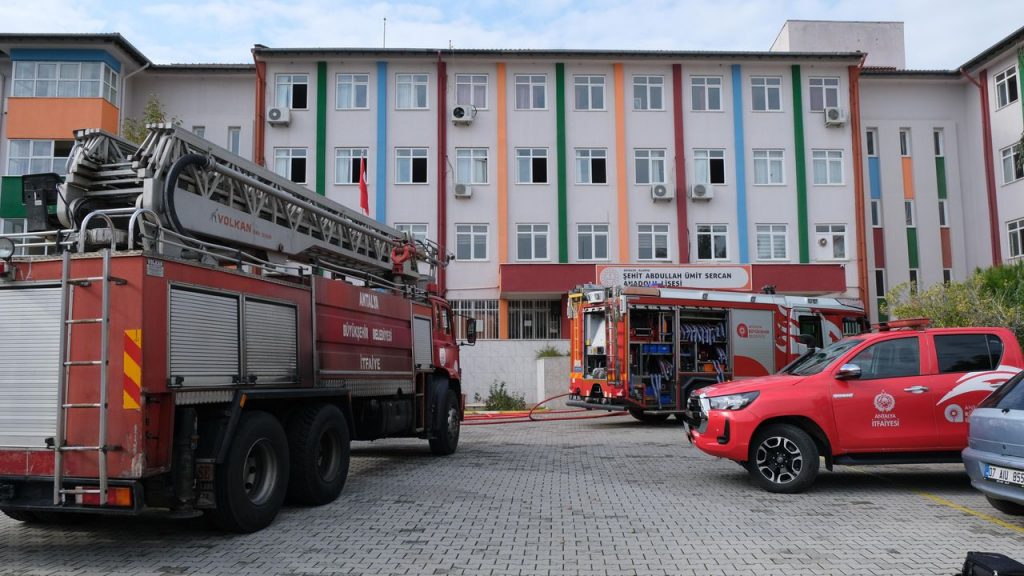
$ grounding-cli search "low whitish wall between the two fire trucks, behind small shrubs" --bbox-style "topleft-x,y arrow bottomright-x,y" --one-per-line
461,340 -> 569,406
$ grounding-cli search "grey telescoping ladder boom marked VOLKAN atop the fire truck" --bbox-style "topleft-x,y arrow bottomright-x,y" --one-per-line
57,124 -> 446,283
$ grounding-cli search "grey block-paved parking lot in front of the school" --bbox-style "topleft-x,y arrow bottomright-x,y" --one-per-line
0,417 -> 1024,576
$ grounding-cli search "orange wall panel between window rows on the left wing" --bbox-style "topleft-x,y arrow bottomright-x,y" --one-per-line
7,98 -> 118,140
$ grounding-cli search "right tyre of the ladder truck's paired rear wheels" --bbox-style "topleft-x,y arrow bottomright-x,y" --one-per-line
288,404 -> 351,506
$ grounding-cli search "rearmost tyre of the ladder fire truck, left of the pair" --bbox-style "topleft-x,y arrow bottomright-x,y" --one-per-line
210,411 -> 289,533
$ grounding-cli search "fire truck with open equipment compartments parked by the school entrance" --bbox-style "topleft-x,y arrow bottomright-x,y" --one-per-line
567,285 -> 867,422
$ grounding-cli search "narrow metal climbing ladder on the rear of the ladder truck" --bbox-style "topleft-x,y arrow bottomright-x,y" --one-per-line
53,249 -> 126,505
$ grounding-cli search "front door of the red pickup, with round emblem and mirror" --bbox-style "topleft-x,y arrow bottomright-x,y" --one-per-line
822,335 -> 938,452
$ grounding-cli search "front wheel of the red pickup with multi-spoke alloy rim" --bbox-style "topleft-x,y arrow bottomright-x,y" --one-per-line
748,424 -> 820,494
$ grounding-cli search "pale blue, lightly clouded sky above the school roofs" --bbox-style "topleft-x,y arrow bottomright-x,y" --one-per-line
0,0 -> 1024,70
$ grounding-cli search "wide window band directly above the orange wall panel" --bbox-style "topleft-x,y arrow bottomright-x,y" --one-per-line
11,61 -> 120,104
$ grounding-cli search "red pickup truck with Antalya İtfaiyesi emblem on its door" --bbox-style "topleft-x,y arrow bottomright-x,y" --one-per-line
687,323 -> 1024,493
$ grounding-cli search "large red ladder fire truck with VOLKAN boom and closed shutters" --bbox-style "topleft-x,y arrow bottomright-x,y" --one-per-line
0,125 -> 475,532
